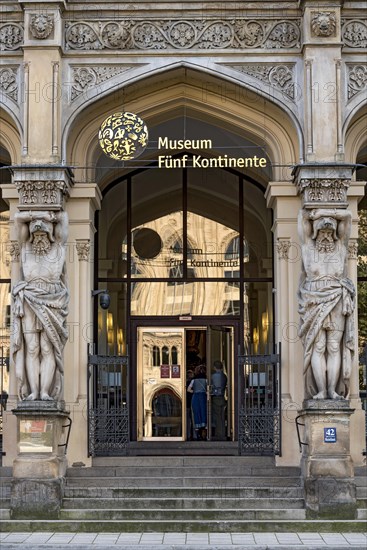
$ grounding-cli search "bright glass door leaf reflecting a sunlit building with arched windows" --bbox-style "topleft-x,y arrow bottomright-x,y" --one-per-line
138,327 -> 186,441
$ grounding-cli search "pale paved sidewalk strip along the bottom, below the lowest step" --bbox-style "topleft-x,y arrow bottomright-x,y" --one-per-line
0,532 -> 367,550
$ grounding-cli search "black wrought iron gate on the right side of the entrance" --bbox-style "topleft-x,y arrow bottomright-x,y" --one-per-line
238,344 -> 281,455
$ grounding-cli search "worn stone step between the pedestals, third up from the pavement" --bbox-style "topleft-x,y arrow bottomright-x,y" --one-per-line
63,495 -> 304,510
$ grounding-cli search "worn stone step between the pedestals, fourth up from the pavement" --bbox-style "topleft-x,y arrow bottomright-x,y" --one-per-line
64,484 -> 303,501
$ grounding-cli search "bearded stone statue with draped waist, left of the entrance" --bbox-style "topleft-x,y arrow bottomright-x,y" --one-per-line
12,211 -> 69,401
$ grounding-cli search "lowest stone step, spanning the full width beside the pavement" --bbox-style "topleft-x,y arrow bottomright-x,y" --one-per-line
1,517 -> 366,533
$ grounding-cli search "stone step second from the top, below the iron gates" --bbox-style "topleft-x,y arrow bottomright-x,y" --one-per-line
66,464 -> 301,478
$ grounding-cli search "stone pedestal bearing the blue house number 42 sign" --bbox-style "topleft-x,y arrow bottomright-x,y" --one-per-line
300,399 -> 356,519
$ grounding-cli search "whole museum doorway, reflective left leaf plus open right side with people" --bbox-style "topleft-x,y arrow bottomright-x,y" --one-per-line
137,324 -> 235,441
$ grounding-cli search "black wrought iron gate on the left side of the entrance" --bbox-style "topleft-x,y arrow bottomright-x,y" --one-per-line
88,354 -> 130,456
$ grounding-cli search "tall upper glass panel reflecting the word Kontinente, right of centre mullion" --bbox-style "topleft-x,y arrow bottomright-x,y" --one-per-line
187,169 -> 240,278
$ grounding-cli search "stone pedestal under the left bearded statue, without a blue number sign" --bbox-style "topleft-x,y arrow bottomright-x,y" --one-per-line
10,401 -> 70,519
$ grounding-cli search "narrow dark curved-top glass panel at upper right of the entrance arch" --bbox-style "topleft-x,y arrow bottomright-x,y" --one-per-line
243,182 -> 272,277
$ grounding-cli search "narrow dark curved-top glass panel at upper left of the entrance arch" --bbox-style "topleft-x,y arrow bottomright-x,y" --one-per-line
98,180 -> 127,277
